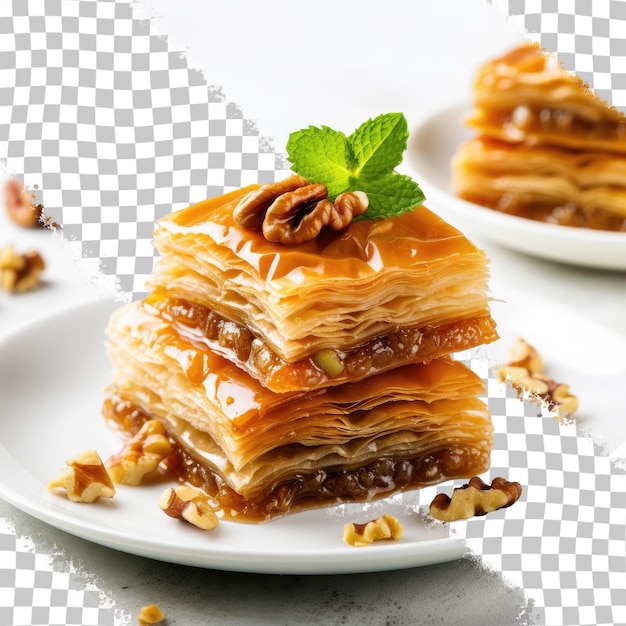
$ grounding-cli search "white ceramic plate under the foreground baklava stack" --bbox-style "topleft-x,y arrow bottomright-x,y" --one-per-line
0,290 -> 626,574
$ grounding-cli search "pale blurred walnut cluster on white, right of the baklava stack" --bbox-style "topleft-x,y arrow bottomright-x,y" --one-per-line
498,339 -> 578,418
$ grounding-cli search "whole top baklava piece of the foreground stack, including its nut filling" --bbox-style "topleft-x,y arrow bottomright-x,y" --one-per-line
143,187 -> 496,393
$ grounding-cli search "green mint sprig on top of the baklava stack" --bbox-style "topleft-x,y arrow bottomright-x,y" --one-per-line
287,113 -> 424,220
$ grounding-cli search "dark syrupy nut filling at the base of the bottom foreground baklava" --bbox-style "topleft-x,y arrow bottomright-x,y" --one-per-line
103,392 -> 490,523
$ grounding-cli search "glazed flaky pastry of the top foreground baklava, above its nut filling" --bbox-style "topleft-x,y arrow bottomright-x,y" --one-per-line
148,186 -> 489,362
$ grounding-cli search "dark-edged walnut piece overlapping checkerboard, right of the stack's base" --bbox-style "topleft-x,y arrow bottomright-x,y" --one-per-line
430,476 -> 522,522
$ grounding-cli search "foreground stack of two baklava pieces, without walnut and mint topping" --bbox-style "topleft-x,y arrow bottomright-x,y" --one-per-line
104,186 -> 497,521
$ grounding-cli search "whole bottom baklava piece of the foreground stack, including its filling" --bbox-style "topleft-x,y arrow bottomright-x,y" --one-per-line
103,346 -> 493,521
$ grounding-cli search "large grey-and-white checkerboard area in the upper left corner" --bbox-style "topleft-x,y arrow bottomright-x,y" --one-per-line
0,0 -> 284,298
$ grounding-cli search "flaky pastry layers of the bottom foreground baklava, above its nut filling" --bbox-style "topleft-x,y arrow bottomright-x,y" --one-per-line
107,303 -> 489,471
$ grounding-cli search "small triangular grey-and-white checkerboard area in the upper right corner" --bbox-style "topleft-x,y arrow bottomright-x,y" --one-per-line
488,0 -> 626,112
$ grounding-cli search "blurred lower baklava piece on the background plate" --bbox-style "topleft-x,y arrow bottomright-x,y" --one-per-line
452,138 -> 626,231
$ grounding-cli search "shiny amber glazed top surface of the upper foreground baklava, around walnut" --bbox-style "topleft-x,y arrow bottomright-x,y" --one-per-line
153,185 -> 484,284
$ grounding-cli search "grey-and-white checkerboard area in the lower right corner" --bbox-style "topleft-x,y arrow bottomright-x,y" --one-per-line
436,357 -> 626,625
